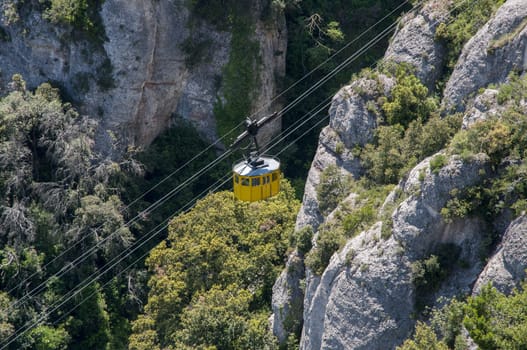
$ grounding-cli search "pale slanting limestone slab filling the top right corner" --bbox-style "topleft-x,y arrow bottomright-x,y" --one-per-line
443,0 -> 527,111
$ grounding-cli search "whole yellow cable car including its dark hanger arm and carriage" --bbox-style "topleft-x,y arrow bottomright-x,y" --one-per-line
231,113 -> 281,202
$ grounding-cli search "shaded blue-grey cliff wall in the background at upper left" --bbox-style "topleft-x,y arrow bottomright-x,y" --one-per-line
0,0 -> 286,150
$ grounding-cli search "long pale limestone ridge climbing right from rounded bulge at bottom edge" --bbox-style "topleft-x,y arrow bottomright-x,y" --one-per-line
301,156 -> 488,349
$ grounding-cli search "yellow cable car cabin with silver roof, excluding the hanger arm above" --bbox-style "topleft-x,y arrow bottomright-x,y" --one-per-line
232,156 -> 280,202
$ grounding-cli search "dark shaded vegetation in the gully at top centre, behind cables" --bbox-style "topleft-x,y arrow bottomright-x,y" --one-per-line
273,0 -> 409,198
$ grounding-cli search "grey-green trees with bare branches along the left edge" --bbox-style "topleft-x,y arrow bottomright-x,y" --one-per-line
0,75 -> 134,349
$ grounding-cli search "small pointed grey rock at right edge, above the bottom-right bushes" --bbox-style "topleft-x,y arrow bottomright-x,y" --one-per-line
473,215 -> 527,294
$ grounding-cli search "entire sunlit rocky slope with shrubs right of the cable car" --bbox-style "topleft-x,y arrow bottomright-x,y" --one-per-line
272,0 -> 527,349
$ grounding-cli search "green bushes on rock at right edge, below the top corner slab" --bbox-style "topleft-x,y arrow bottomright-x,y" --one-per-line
441,76 -> 527,222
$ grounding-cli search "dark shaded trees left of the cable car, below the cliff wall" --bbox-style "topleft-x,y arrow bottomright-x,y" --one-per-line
119,119 -> 230,239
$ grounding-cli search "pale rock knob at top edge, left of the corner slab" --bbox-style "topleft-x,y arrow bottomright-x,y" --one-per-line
384,0 -> 450,90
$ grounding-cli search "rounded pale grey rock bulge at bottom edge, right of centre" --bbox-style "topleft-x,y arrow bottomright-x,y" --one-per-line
300,223 -> 413,349
